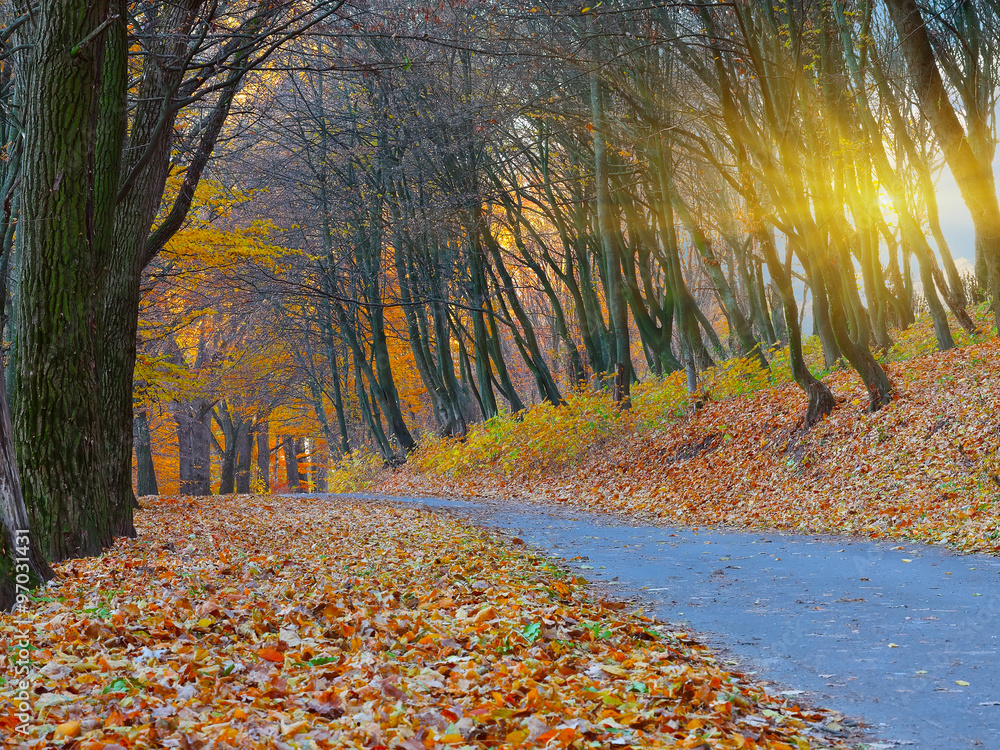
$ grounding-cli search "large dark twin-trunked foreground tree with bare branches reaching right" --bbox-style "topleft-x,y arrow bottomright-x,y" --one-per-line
6,0 -> 339,560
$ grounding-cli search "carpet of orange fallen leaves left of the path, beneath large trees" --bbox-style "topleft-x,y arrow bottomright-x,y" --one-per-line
0,496 -> 841,750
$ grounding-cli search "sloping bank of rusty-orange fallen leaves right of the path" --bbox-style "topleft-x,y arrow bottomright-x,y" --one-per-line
372,338 -> 1000,554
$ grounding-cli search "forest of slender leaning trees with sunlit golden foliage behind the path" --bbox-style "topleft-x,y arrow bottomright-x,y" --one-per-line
78,3 -> 1000,506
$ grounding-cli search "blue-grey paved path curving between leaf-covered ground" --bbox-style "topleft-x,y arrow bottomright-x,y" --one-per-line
324,496 -> 1000,750
